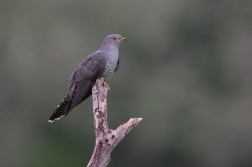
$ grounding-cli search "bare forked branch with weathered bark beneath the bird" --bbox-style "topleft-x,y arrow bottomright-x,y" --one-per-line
87,78 -> 142,167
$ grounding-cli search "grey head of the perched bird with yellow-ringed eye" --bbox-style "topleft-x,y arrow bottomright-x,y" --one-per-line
102,34 -> 128,48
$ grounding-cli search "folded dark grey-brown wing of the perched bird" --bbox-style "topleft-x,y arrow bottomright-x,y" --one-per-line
65,52 -> 106,115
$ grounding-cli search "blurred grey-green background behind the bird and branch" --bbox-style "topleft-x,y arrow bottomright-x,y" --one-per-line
0,0 -> 252,167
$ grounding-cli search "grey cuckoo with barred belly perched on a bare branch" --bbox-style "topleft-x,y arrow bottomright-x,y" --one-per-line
49,34 -> 128,123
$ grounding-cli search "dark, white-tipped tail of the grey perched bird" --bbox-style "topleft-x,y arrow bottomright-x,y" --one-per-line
49,95 -> 72,123
